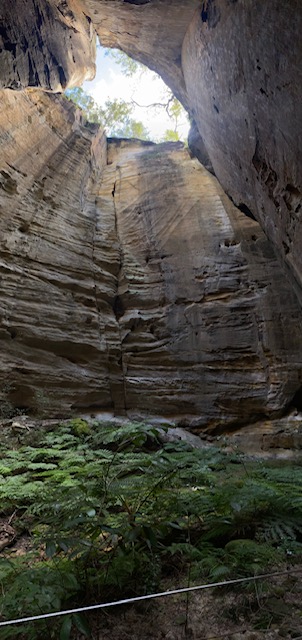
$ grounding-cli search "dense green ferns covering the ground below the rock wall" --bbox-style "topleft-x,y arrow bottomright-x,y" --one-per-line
0,419 -> 302,640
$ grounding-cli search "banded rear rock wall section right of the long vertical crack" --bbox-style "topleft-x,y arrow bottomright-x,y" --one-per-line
107,142 -> 301,428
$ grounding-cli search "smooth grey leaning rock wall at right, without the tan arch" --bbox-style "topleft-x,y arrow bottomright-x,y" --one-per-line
182,0 -> 302,292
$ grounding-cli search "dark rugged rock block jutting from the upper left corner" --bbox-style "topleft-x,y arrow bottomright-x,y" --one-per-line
0,0 -> 95,91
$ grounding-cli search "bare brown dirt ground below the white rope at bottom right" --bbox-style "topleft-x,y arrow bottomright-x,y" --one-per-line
77,566 -> 302,640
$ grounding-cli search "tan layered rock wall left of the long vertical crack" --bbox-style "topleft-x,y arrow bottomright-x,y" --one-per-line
0,90 -> 113,413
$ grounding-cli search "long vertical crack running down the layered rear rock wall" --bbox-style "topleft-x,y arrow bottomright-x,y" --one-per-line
76,125 -> 125,413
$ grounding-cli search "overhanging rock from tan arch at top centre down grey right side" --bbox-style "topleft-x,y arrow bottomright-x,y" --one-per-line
83,0 -> 302,295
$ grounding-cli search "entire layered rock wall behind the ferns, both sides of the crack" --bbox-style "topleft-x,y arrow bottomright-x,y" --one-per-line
0,91 -> 302,429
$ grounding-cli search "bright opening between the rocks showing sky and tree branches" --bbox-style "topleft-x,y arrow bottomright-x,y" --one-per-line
66,44 -> 190,143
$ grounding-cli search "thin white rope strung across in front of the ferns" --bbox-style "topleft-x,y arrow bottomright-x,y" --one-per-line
0,568 -> 302,627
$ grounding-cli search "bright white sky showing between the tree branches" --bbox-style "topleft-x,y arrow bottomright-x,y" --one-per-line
83,46 -> 189,142
